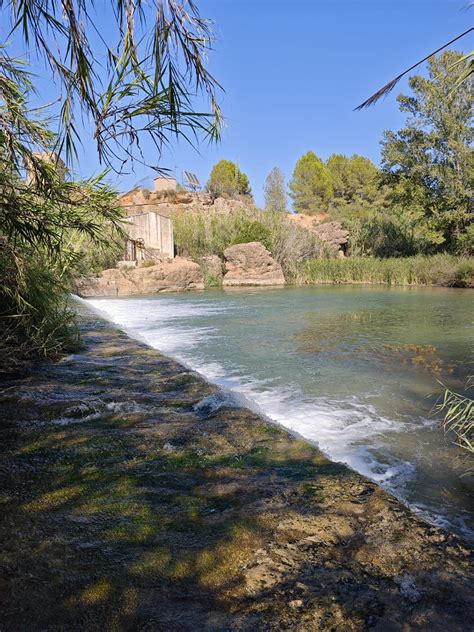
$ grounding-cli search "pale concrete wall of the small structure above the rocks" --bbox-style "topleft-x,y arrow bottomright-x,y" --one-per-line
127,212 -> 174,257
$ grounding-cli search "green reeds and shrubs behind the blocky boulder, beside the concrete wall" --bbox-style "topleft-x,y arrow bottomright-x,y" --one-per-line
173,208 -> 327,280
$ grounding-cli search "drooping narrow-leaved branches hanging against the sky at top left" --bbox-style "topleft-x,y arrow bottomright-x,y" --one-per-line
0,0 -> 221,170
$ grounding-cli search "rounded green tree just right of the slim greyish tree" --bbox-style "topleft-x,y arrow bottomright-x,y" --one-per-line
289,151 -> 333,215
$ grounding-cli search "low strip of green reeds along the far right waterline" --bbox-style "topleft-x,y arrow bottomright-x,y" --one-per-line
295,254 -> 474,287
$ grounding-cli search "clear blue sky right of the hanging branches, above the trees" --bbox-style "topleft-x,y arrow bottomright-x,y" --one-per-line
0,0 -> 473,204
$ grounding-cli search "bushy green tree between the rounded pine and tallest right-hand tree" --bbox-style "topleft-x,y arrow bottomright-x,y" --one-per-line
326,154 -> 379,204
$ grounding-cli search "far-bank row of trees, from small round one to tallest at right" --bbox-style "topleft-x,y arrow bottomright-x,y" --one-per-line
212,51 -> 474,257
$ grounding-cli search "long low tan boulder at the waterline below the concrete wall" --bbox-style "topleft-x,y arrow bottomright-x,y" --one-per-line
76,257 -> 204,298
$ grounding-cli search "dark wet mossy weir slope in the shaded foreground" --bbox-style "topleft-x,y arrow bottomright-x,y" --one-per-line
0,304 -> 473,630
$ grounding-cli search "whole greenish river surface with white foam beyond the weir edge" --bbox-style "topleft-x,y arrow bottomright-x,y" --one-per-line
89,286 -> 474,537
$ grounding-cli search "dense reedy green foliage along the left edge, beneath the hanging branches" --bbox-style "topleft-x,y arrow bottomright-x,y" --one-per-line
0,55 -> 121,372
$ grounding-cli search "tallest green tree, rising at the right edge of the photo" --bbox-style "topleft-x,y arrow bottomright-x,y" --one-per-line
382,51 -> 474,251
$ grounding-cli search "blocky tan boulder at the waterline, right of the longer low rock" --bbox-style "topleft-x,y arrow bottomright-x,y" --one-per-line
223,241 -> 285,287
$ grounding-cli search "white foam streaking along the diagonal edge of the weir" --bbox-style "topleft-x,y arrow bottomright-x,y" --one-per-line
83,297 -> 472,531
